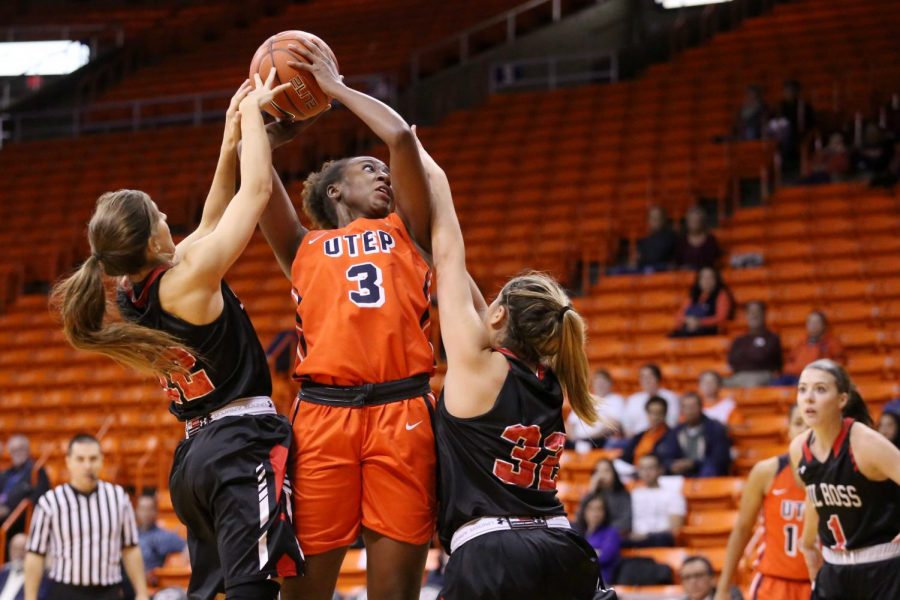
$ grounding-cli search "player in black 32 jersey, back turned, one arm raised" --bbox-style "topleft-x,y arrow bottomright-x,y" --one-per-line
420,136 -> 600,600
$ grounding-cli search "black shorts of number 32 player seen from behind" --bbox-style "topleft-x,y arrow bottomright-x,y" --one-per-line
440,529 -> 600,600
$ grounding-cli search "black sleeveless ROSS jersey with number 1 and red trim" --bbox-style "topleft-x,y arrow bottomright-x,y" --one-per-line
797,419 -> 900,550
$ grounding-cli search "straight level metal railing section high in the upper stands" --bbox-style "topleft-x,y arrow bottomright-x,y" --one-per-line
489,52 -> 619,94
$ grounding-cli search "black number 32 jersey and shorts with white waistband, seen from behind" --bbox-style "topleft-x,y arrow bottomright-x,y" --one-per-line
435,349 -> 598,600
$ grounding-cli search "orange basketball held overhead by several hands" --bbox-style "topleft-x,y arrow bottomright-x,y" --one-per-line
250,30 -> 337,121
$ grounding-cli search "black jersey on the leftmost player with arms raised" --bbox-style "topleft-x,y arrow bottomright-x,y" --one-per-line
117,268 -> 272,421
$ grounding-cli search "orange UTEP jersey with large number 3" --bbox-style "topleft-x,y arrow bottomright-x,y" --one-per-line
291,213 -> 434,385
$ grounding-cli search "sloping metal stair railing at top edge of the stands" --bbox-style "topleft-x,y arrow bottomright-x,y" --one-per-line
410,0 -> 606,83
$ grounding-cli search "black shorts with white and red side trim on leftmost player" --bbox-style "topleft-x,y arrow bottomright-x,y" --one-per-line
169,415 -> 303,600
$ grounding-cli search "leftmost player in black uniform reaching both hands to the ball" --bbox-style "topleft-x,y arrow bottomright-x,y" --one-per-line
54,75 -> 303,600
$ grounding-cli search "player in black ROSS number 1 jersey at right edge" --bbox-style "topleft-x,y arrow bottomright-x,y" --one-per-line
791,360 -> 900,600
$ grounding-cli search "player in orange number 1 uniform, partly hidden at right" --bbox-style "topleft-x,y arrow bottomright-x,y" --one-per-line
716,404 -> 810,600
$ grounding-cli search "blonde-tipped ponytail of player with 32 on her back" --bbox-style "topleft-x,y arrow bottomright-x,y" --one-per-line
551,309 -> 597,423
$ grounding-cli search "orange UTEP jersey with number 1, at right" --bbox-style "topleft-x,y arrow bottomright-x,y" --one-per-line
757,454 -> 809,581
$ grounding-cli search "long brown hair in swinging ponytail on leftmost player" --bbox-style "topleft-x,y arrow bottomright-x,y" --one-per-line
50,190 -> 192,375
